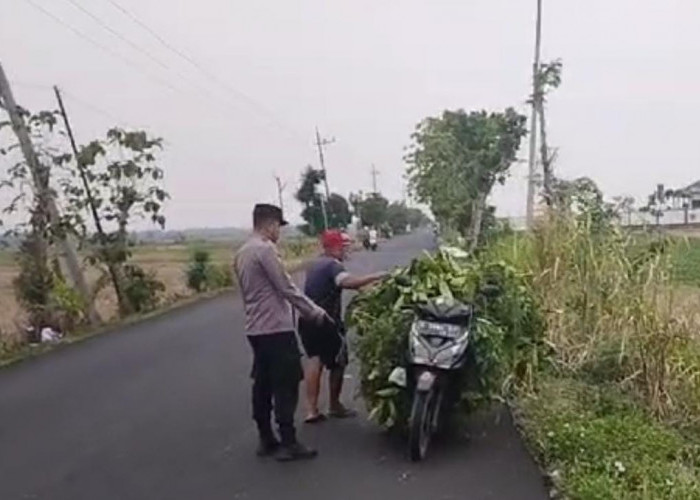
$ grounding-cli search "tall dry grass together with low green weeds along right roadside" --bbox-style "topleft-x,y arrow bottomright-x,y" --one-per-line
489,220 -> 700,500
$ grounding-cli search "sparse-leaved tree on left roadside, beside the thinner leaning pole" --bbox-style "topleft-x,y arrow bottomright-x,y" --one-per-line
61,128 -> 169,314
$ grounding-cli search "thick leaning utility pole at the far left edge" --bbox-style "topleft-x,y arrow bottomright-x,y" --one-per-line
0,64 -> 100,324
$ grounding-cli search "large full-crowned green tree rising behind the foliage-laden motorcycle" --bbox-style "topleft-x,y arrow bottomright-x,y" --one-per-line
406,108 -> 527,249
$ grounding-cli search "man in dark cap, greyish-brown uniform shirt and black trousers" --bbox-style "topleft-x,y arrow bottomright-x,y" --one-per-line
235,205 -> 328,461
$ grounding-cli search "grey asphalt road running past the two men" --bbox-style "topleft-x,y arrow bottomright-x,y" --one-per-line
0,234 -> 547,500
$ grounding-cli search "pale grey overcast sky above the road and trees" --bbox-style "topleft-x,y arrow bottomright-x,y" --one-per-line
0,0 -> 700,228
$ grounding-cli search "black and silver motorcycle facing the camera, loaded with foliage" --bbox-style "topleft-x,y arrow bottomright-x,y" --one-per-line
389,284 -> 495,462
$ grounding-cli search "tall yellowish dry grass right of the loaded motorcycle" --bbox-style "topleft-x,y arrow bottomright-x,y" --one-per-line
489,213 -> 700,428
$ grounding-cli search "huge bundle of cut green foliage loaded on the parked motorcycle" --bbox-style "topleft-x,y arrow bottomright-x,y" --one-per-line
348,251 -> 542,428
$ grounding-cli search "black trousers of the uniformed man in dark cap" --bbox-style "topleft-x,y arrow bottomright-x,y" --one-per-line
248,332 -> 304,445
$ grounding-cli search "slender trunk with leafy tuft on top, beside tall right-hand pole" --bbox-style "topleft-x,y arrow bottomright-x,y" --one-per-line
532,59 -> 563,206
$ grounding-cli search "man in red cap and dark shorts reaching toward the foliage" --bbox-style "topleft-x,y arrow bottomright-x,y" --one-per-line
299,230 -> 387,423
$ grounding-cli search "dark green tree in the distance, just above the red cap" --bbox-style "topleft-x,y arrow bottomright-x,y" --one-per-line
296,166 -> 352,236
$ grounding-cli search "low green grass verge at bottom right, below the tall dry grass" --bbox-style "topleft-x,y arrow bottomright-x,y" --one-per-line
517,376 -> 700,500
